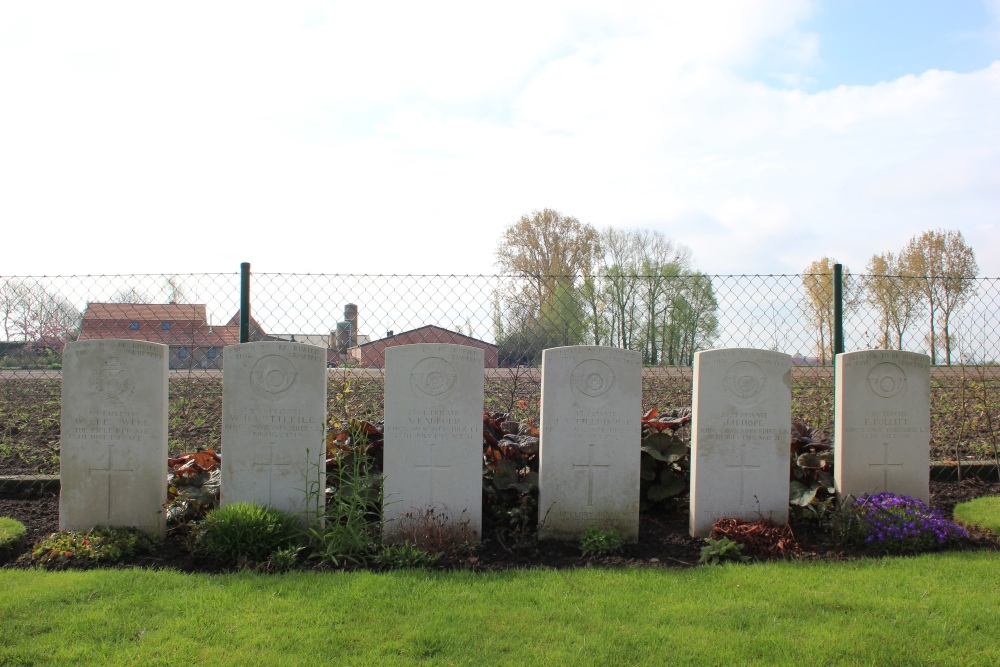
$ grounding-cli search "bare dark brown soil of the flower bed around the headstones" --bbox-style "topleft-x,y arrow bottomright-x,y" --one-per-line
0,480 -> 1000,572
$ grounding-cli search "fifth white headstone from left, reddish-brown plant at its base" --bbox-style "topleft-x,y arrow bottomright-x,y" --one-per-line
690,349 -> 792,537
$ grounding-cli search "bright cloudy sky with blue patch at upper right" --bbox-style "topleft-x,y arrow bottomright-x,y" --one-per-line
0,0 -> 1000,277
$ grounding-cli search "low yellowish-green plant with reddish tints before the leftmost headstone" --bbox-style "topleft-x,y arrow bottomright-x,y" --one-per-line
22,526 -> 155,568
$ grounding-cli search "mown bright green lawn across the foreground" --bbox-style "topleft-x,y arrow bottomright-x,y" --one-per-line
0,552 -> 1000,667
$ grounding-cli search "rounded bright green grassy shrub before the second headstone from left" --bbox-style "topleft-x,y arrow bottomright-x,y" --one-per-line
193,502 -> 302,567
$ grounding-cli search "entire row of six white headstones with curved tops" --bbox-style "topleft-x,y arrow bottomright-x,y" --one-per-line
60,340 -> 930,541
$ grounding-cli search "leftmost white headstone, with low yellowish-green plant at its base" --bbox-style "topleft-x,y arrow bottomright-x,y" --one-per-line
59,339 -> 169,538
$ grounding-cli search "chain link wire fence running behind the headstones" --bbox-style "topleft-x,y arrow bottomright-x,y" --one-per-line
0,272 -> 1000,474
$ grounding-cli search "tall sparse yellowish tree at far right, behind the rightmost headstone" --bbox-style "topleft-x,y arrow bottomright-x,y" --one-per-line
899,229 -> 979,366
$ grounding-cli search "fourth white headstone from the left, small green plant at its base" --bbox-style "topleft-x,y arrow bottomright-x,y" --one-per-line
538,346 -> 642,542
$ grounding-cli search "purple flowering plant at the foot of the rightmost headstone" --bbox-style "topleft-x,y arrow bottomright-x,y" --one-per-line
846,493 -> 968,553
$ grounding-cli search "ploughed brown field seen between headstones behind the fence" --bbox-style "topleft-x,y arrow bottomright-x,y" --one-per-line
0,366 -> 1000,475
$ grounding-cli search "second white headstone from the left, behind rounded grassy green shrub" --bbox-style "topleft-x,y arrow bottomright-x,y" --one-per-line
221,341 -> 326,521
